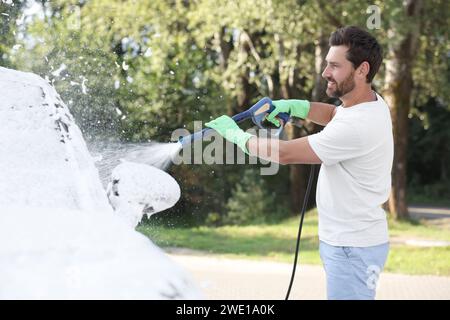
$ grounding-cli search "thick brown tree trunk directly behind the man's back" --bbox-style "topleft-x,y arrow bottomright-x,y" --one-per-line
384,0 -> 420,219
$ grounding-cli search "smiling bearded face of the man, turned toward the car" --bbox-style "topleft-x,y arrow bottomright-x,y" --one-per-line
322,46 -> 355,98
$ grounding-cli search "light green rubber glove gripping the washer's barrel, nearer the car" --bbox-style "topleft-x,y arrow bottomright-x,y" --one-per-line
205,115 -> 253,154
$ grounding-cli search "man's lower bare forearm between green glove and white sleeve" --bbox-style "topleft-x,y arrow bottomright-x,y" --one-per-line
247,136 -> 322,164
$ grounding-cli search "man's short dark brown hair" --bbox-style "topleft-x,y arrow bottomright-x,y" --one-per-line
329,26 -> 383,83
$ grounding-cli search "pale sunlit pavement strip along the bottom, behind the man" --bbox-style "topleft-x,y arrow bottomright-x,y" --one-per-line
169,253 -> 450,300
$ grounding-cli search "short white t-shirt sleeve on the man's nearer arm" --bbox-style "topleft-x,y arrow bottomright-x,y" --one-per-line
308,119 -> 363,165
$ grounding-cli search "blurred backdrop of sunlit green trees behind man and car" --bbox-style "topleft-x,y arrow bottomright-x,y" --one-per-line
0,0 -> 450,226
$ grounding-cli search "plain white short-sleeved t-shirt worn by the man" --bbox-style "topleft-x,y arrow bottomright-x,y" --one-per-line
308,94 -> 394,247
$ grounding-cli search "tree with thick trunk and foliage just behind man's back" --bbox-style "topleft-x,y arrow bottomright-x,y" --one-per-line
384,0 -> 449,218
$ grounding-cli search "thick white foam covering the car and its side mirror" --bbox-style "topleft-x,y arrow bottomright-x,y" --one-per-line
0,67 -> 200,299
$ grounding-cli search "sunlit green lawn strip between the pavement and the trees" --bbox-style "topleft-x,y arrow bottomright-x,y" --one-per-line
138,210 -> 450,276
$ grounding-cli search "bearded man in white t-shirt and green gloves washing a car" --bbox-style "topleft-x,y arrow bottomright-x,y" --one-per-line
206,27 -> 393,299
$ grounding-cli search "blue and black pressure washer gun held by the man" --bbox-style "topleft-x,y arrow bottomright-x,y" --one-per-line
178,97 -> 289,147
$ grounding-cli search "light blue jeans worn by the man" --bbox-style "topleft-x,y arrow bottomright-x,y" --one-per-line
319,241 -> 389,300
